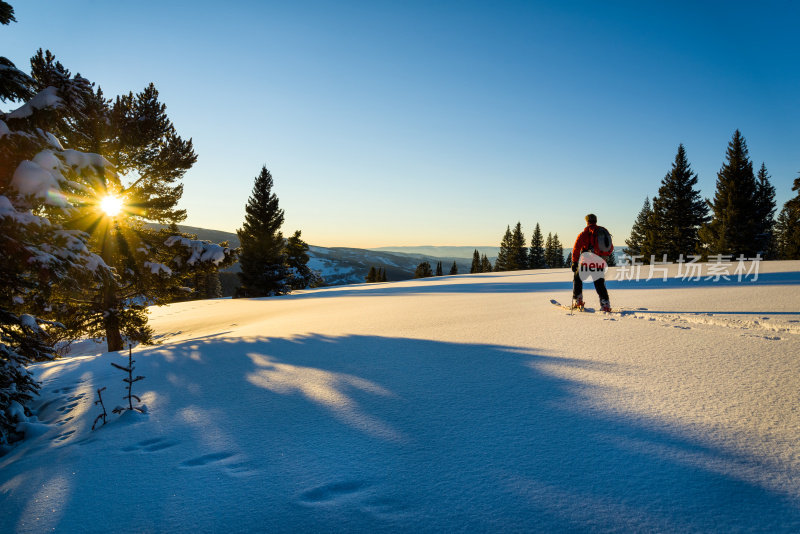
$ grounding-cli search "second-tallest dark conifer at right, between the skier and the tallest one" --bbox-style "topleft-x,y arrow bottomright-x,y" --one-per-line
650,144 -> 709,261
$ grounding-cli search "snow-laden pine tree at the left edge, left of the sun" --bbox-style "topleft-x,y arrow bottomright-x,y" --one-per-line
0,30 -> 113,446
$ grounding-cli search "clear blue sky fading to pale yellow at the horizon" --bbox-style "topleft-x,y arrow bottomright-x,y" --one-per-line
0,0 -> 800,247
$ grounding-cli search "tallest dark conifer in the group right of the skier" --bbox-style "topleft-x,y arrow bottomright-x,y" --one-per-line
700,130 -> 760,257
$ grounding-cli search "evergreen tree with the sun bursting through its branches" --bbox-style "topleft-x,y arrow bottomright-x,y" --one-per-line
24,50 -> 235,351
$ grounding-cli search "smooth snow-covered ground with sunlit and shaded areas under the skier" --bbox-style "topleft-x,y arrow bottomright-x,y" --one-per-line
0,262 -> 800,533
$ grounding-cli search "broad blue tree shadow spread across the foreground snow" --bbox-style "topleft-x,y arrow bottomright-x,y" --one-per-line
6,335 -> 800,532
